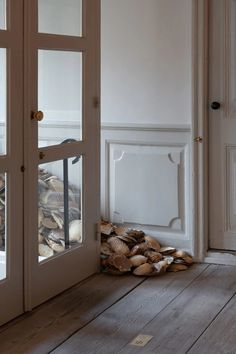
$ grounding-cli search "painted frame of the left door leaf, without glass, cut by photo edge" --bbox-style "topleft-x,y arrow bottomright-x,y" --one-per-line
0,0 -> 23,324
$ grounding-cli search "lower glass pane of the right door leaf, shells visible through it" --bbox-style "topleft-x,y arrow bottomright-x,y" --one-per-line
38,157 -> 83,262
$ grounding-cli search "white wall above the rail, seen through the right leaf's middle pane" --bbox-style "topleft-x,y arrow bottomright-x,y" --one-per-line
38,50 -> 82,119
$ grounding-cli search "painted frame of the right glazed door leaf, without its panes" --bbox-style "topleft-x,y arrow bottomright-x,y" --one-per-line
25,0 -> 100,309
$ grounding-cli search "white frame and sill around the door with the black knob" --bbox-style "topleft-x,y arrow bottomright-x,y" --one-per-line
195,0 -> 236,265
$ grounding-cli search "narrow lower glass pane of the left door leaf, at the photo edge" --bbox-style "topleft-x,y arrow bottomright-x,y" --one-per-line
0,173 -> 7,280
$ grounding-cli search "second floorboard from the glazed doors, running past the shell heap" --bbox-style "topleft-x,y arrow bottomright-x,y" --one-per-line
53,264 -> 207,354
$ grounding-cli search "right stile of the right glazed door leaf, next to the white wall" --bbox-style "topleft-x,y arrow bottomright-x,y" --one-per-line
84,0 -> 101,258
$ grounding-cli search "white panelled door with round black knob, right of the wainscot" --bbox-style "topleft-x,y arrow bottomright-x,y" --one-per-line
209,0 -> 236,250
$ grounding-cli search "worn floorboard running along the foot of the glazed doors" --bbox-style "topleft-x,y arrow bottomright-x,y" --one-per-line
0,274 -> 145,354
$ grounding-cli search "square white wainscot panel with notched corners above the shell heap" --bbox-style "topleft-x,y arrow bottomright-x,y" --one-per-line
109,143 -> 182,229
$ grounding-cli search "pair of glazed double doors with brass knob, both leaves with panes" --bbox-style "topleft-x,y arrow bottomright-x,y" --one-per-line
0,0 -> 100,322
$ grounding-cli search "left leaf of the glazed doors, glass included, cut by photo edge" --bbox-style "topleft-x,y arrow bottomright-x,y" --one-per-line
0,0 -> 23,325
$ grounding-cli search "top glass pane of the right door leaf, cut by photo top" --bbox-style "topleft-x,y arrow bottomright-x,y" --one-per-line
38,0 -> 82,36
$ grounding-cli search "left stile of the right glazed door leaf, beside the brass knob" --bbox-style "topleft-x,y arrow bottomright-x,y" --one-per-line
24,0 -> 37,311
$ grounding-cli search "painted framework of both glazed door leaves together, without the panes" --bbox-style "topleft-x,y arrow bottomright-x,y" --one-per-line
0,0 -> 100,324
